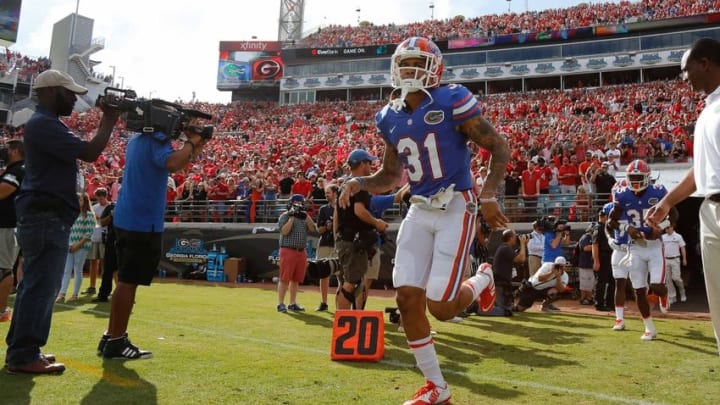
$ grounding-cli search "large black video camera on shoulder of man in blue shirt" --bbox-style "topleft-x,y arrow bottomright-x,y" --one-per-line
95,87 -> 215,140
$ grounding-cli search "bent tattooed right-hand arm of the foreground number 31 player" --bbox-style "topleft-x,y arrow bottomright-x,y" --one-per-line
460,116 -> 510,198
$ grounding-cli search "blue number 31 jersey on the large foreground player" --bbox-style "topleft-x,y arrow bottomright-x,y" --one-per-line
375,84 -> 482,197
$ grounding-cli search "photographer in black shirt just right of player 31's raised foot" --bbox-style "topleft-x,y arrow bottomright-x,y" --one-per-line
478,229 -> 530,316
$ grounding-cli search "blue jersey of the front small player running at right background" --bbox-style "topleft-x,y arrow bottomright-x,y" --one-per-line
613,184 -> 668,243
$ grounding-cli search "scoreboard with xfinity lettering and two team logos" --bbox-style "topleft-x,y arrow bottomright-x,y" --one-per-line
217,41 -> 283,90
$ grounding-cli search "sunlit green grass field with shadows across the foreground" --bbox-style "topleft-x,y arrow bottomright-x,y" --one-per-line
0,282 -> 720,405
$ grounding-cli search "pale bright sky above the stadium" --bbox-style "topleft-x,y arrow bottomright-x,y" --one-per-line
10,0 -> 608,102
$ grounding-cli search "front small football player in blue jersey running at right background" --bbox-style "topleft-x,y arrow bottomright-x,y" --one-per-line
607,159 -> 678,341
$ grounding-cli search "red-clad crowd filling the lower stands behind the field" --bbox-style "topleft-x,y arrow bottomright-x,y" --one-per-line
0,76 -> 703,221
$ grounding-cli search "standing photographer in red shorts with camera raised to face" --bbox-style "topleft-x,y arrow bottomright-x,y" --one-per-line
277,194 -> 318,312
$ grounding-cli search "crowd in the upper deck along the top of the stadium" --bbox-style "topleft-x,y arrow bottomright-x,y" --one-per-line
296,0 -> 720,47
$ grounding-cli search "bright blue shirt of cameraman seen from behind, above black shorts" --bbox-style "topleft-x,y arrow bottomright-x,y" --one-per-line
113,132 -> 174,232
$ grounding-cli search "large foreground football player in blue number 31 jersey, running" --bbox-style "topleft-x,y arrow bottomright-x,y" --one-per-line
339,37 -> 510,405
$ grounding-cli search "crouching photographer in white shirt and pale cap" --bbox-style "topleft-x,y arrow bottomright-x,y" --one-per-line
513,256 -> 569,313
